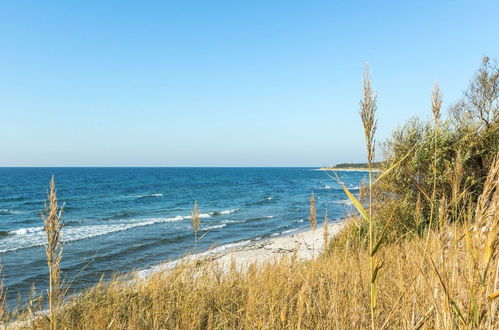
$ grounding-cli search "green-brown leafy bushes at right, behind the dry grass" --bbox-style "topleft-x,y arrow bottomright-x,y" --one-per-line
348,58 -> 499,243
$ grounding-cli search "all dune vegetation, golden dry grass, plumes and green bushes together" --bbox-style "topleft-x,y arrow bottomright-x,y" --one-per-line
0,58 -> 499,329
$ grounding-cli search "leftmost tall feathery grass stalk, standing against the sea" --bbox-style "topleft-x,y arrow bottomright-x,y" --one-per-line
41,176 -> 64,329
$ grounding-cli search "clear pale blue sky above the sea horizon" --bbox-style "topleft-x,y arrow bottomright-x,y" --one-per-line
0,0 -> 499,166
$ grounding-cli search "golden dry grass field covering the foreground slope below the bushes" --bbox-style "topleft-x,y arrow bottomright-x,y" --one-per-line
27,217 -> 499,329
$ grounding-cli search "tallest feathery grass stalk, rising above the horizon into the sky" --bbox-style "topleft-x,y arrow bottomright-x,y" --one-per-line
360,63 -> 381,329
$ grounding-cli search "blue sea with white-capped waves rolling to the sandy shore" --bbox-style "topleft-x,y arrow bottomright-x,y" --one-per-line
0,168 -> 366,300
